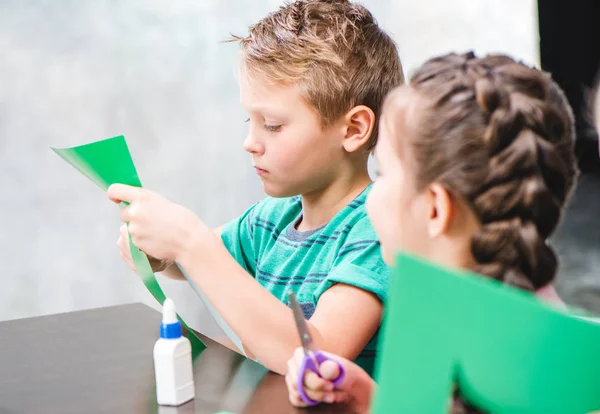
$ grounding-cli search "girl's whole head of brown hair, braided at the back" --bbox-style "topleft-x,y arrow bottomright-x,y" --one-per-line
390,53 -> 577,414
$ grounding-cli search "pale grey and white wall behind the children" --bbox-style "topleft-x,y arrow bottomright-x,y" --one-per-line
0,0 -> 596,336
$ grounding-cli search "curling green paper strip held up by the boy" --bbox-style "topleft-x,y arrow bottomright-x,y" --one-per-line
51,135 -> 245,356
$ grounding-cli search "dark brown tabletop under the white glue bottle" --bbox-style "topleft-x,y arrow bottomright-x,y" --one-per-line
0,304 -> 356,414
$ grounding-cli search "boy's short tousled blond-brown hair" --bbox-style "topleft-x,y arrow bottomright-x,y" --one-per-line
233,0 -> 404,150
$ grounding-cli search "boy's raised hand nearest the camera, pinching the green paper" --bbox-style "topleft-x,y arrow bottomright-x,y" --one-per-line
107,184 -> 214,261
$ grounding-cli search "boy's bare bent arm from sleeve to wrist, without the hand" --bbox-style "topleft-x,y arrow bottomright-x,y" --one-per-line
179,237 -> 383,374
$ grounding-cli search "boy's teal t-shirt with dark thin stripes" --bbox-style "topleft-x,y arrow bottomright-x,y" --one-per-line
221,185 -> 390,375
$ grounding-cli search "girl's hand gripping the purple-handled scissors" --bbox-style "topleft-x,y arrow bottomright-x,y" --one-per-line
285,348 -> 374,413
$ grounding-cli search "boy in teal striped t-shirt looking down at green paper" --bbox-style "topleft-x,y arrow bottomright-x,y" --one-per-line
108,0 -> 403,374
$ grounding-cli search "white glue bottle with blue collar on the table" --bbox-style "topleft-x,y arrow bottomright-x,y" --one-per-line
154,298 -> 195,406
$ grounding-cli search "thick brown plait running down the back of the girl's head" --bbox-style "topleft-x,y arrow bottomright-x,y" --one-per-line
471,64 -> 567,290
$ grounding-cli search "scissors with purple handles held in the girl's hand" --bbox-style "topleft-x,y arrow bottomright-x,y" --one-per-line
288,291 -> 345,405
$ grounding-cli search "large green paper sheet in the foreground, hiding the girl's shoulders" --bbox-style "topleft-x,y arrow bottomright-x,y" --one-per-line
372,254 -> 600,414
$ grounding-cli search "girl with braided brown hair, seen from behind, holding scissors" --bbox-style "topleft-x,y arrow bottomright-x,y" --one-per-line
286,53 -> 577,413
